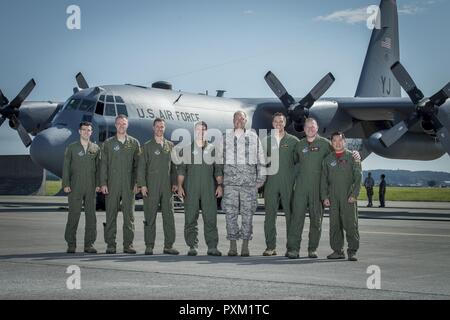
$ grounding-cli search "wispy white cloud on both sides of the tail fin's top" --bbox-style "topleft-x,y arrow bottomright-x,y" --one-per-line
314,0 -> 428,24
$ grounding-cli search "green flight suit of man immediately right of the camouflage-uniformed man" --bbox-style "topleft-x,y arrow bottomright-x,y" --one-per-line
264,133 -> 299,250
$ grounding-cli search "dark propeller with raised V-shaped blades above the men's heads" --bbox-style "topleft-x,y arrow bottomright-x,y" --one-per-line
264,71 -> 335,131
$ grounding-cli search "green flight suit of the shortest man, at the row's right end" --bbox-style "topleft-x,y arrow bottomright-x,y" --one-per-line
320,150 -> 361,253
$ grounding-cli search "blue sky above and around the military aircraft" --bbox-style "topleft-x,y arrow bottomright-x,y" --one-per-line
0,0 -> 450,172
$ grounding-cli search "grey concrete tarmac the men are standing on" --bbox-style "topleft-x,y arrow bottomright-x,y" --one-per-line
0,196 -> 450,300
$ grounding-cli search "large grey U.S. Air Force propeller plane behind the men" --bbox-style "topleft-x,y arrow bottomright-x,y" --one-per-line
0,0 -> 450,177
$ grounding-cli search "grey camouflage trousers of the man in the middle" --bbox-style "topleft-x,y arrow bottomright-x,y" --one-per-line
222,186 -> 257,240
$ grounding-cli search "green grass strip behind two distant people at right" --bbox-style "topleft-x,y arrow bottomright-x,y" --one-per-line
358,187 -> 450,202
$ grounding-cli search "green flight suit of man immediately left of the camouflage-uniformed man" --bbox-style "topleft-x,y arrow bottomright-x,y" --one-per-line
177,142 -> 223,249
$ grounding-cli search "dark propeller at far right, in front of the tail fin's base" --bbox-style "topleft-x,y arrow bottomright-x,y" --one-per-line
380,61 -> 450,154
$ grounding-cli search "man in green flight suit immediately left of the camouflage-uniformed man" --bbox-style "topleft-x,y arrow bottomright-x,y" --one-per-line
177,121 -> 223,256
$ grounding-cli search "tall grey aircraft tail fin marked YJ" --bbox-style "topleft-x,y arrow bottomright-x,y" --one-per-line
355,0 -> 401,97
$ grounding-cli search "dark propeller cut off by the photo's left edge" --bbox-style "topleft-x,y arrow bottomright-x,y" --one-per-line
0,79 -> 36,147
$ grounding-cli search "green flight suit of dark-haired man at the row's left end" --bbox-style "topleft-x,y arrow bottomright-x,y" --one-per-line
62,141 -> 100,248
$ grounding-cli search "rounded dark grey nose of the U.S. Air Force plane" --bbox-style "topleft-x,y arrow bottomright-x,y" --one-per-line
30,127 -> 77,177
